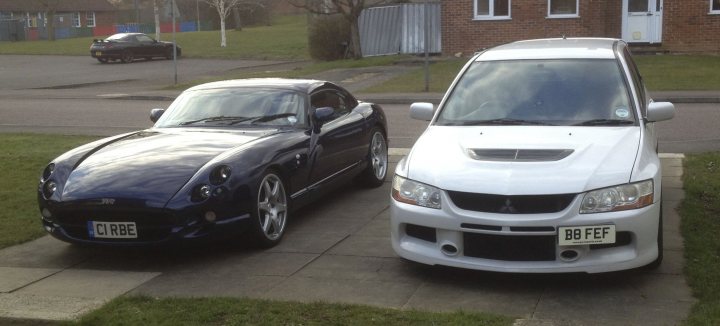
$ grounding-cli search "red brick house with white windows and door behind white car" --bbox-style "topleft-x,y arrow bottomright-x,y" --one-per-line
441,0 -> 720,54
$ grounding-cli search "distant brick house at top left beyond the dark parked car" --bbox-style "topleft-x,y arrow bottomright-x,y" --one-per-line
0,0 -> 116,40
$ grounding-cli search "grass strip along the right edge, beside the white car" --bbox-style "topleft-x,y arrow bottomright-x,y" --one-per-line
680,153 -> 720,325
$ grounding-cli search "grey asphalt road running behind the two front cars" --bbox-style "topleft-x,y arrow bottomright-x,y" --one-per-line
0,55 -> 720,153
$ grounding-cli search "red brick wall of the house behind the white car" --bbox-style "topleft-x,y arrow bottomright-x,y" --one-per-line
441,0 -> 720,55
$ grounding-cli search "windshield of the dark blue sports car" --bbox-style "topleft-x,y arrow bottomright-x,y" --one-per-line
155,88 -> 307,127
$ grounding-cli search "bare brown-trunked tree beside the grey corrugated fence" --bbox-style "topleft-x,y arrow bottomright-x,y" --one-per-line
288,0 -> 390,59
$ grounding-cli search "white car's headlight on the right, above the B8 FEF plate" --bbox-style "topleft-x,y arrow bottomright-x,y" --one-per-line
580,180 -> 655,214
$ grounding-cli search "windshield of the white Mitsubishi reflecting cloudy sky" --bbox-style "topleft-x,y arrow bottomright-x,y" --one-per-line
436,59 -> 635,126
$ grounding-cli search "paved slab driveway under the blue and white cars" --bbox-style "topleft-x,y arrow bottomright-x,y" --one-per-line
0,155 -> 693,325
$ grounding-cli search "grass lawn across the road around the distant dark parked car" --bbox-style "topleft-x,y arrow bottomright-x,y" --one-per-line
0,15 -> 309,60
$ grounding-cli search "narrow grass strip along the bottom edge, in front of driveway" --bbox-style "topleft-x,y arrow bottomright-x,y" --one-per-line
74,297 -> 513,326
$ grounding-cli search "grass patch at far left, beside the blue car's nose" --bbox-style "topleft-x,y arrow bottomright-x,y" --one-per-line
0,134 -> 95,248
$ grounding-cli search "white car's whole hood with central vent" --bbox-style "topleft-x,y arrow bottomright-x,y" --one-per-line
406,126 -> 641,195
